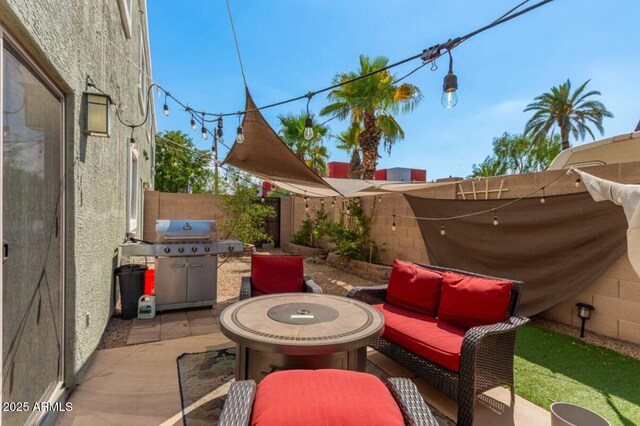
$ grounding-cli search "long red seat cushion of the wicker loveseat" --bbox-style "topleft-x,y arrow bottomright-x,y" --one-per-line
373,303 -> 465,371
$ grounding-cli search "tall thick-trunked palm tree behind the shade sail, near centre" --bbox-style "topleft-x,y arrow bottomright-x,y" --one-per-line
320,55 -> 422,179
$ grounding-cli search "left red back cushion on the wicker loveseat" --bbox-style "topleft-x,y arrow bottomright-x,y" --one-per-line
387,259 -> 442,316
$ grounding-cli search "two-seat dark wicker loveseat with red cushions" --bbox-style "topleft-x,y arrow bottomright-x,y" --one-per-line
348,260 -> 528,426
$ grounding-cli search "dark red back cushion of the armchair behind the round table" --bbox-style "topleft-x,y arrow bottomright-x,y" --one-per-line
251,256 -> 304,294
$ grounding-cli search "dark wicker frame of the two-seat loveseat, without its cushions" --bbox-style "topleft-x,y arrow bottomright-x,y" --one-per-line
347,263 -> 529,426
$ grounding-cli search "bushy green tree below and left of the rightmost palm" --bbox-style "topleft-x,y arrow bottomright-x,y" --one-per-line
471,132 -> 562,177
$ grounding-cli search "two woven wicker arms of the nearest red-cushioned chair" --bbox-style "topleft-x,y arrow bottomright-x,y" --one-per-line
218,378 -> 438,426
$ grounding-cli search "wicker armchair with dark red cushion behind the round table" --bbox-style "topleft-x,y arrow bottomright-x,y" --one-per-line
240,255 -> 322,300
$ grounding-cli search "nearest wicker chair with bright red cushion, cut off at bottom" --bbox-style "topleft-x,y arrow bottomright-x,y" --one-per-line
218,369 -> 438,426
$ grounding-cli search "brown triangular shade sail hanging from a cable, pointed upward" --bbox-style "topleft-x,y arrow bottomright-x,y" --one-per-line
223,89 -> 332,194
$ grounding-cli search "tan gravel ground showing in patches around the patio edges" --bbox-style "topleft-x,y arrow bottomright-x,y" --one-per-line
98,250 -> 640,359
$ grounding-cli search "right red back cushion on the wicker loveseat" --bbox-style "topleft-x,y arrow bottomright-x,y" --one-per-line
438,272 -> 511,329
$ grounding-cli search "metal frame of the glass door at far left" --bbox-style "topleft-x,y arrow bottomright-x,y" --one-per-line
0,23 -> 67,423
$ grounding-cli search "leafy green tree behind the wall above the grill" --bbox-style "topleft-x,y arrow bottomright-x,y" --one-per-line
155,130 -> 215,193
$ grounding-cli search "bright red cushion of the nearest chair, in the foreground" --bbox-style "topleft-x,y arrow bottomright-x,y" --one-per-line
251,370 -> 404,426
